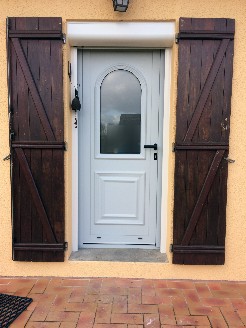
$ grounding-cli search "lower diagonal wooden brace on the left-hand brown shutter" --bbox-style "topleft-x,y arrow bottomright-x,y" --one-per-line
15,148 -> 57,243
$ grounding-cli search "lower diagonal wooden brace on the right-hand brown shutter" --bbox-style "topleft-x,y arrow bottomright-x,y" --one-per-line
181,150 -> 225,246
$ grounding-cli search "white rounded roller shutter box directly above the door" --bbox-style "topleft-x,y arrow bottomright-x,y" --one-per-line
67,22 -> 175,48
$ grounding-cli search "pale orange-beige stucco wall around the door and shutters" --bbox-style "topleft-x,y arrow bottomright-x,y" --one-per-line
0,0 -> 246,280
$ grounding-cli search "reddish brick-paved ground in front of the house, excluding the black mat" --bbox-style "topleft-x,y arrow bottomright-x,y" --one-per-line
0,277 -> 246,328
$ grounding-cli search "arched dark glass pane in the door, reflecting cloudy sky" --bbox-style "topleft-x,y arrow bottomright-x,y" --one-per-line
100,70 -> 141,154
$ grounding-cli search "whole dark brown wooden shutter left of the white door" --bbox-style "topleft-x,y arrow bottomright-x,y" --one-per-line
8,18 -> 64,262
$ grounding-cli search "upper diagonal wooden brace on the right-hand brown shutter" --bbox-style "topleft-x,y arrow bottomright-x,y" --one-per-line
184,39 -> 230,142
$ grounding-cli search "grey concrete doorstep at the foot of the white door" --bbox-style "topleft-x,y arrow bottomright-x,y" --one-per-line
69,248 -> 168,263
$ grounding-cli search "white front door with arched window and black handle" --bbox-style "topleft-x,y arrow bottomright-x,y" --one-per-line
78,50 -> 164,248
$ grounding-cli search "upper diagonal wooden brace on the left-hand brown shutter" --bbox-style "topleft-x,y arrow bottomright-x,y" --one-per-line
11,38 -> 56,141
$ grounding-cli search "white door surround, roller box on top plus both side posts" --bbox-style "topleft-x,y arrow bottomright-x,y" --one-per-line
67,22 -> 175,253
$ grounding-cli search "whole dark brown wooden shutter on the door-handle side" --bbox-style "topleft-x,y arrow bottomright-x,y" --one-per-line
172,18 -> 235,264
